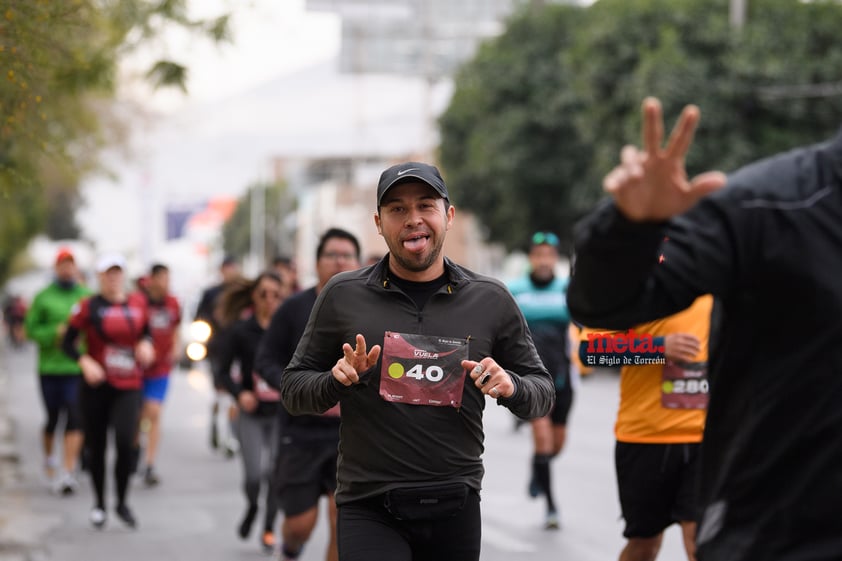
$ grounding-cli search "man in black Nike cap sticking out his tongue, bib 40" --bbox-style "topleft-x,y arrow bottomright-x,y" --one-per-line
281,162 -> 555,561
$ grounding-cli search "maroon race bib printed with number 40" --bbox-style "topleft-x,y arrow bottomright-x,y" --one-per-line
380,331 -> 468,407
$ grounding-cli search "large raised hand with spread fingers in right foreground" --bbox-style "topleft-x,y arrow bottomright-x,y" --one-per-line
603,97 -> 726,222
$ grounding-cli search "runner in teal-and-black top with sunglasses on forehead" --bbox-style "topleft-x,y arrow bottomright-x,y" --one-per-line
509,232 -> 573,530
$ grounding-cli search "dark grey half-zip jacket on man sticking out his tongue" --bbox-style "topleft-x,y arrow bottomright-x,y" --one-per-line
281,256 -> 555,504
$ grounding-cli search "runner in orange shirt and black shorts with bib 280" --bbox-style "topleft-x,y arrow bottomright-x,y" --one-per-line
580,295 -> 713,561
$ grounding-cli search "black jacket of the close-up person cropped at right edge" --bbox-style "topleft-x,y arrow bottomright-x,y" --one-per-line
568,129 -> 842,561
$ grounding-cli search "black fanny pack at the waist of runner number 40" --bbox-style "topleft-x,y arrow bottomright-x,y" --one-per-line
383,483 -> 471,520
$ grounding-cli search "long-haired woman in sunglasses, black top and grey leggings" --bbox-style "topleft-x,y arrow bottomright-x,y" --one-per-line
220,271 -> 283,553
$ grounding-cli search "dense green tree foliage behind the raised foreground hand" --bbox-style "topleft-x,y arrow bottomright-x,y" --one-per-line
440,0 -> 842,249
